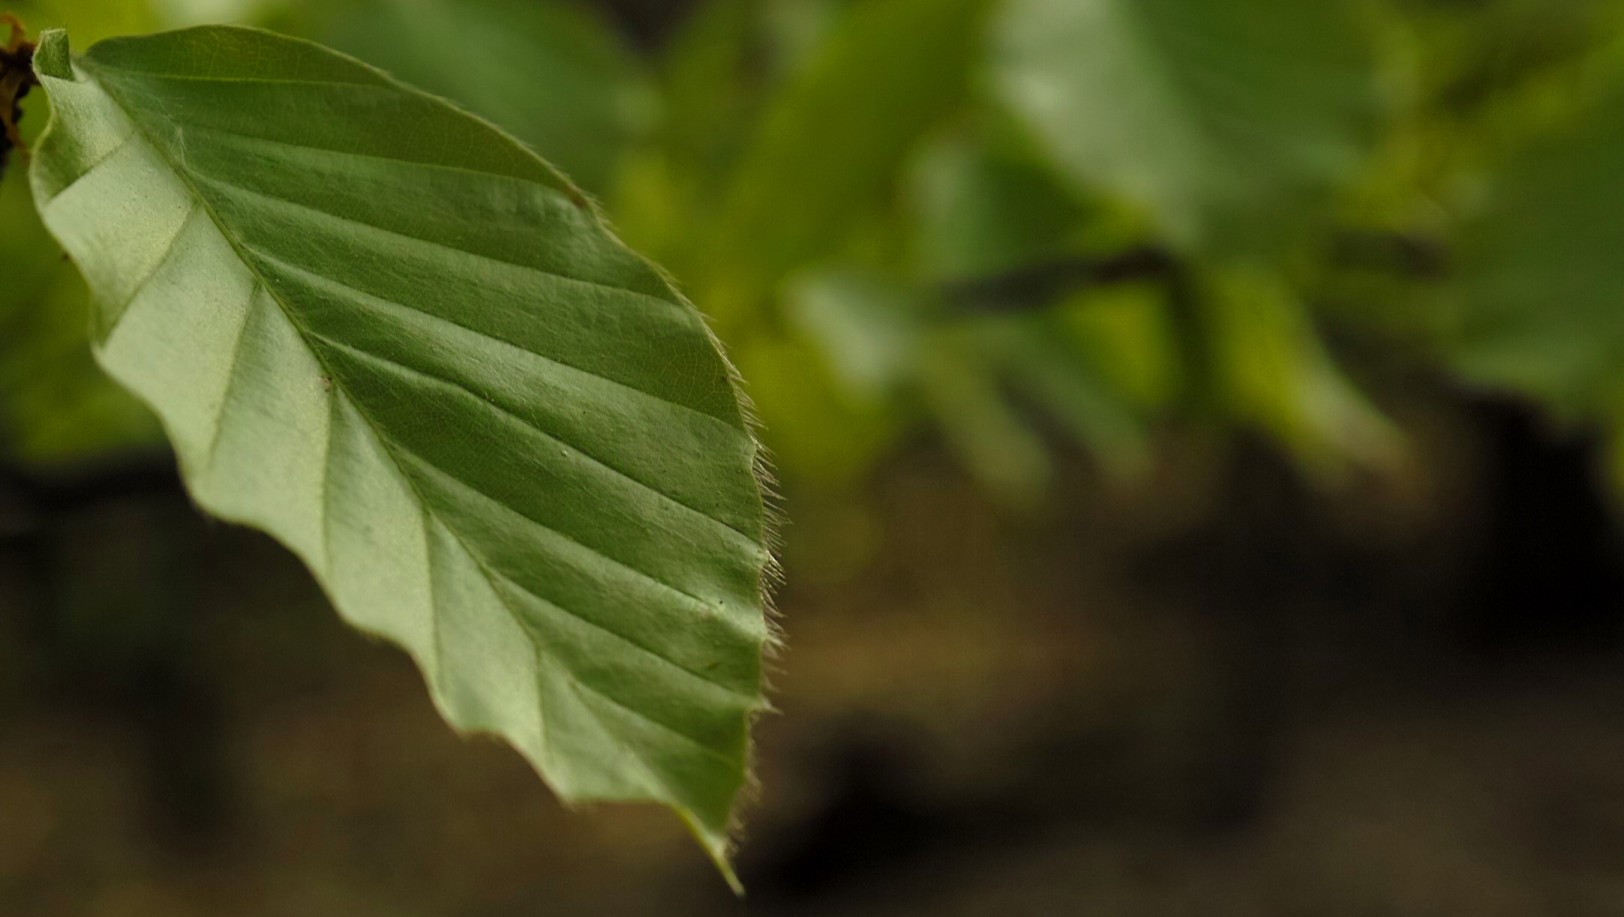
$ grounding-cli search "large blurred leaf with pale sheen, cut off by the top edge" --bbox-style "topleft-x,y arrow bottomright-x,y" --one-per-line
992,0 -> 1372,247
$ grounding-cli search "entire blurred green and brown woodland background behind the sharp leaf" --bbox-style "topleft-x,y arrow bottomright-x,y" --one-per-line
9,0 -> 1624,917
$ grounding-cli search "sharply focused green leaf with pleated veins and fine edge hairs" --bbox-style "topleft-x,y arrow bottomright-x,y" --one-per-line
32,28 -> 770,875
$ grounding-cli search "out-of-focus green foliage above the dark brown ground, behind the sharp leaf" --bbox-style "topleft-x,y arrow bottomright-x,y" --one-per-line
9,0 -> 1624,505
